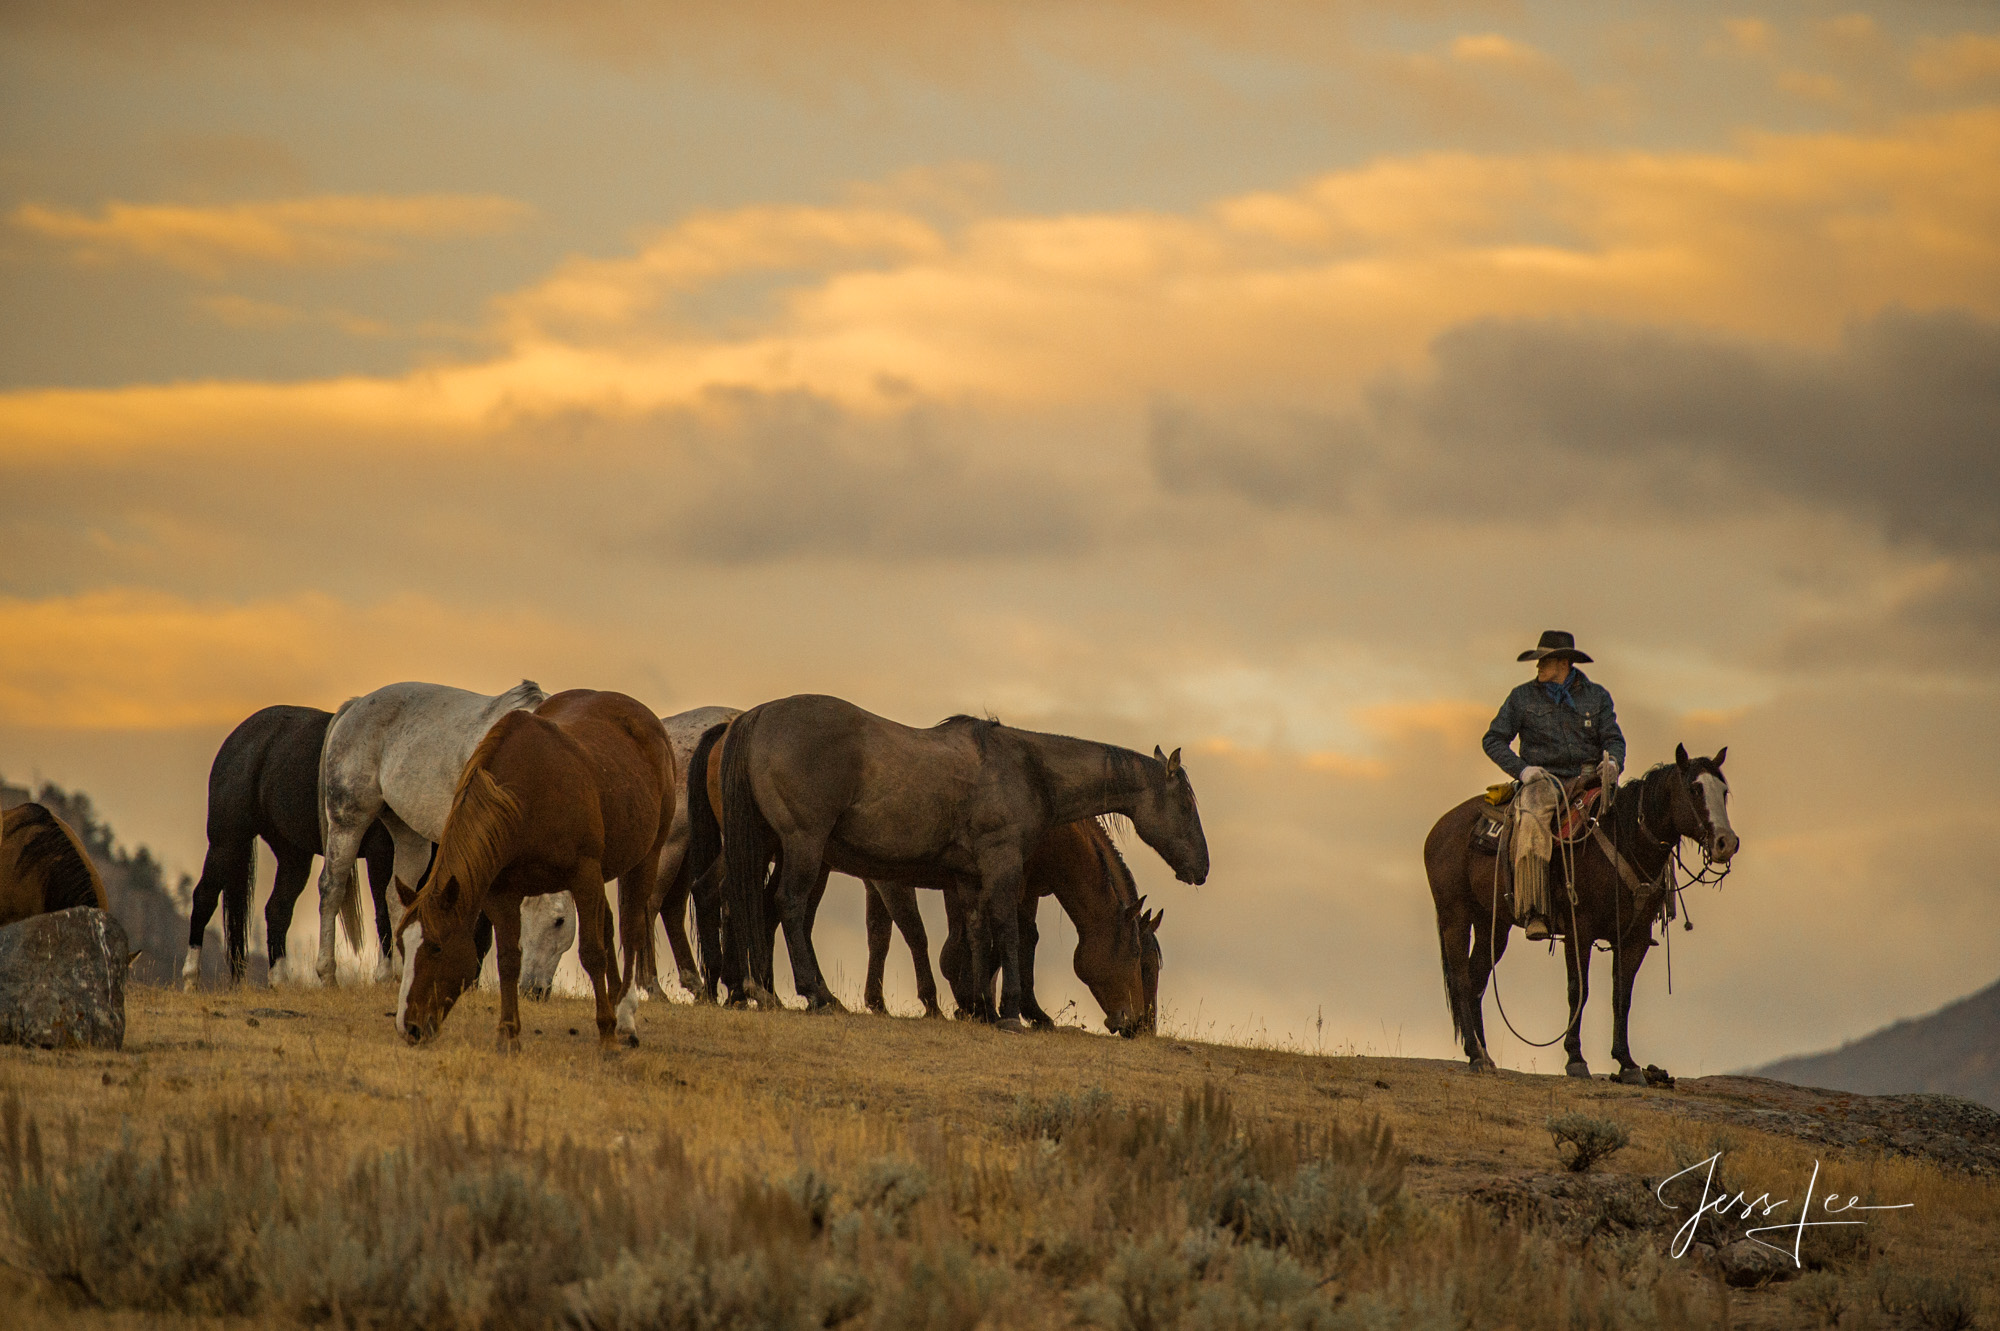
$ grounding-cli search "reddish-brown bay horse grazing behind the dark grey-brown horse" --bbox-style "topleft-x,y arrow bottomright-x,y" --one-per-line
866,817 -> 1164,1035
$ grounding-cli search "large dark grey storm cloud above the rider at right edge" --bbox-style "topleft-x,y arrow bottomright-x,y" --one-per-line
1152,312 -> 2000,554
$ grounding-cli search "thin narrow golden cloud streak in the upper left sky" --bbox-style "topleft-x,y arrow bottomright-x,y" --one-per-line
10,194 -> 532,278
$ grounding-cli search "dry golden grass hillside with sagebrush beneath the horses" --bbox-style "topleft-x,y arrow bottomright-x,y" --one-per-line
0,985 -> 2000,1329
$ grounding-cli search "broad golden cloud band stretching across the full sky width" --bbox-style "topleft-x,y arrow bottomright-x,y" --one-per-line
0,108 -> 2000,445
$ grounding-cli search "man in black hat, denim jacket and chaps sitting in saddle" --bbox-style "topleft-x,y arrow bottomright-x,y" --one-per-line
1482,630 -> 1624,941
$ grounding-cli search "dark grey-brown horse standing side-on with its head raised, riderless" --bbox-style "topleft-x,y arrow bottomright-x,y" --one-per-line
722,693 -> 1208,1029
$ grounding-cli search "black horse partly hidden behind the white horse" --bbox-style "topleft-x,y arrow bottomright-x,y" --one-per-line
180,707 -> 396,989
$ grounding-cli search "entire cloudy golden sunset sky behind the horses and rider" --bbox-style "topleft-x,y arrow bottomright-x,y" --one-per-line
0,0 -> 2000,1073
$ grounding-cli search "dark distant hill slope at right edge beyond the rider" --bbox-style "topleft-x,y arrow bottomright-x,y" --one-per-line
1752,981 -> 2000,1109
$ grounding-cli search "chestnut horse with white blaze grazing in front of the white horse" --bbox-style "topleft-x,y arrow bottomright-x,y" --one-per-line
396,689 -> 674,1049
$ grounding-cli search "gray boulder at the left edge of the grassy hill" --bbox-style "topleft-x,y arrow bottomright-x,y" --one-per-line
0,905 -> 132,1049
